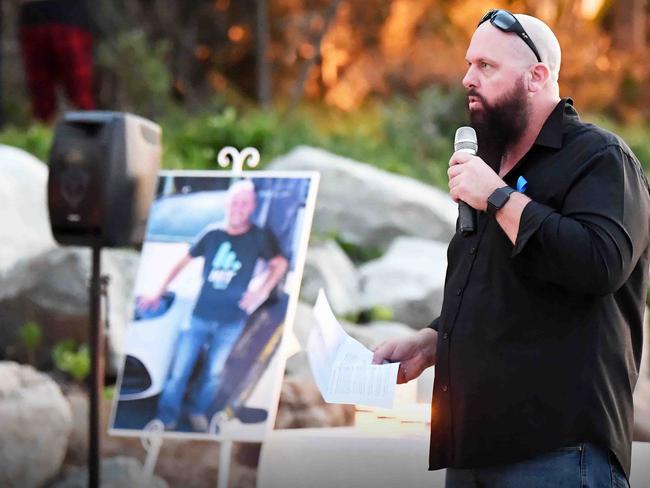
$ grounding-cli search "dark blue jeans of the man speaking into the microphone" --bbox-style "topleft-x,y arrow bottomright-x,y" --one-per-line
445,443 -> 630,488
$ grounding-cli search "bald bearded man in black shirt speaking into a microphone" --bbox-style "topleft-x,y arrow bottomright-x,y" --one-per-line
373,10 -> 650,488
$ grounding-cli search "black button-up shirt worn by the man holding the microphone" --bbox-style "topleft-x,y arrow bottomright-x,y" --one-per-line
429,99 -> 650,475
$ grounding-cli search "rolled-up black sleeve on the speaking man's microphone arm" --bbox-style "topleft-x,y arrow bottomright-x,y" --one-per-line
512,145 -> 648,295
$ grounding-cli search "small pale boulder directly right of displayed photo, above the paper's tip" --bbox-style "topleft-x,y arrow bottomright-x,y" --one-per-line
300,240 -> 361,315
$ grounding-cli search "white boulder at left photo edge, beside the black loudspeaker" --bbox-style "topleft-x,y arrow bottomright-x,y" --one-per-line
0,145 -> 55,273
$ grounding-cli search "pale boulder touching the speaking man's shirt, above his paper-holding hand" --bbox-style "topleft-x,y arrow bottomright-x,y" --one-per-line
360,237 -> 447,328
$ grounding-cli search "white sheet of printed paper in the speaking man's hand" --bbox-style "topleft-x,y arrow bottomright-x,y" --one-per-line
307,290 -> 399,408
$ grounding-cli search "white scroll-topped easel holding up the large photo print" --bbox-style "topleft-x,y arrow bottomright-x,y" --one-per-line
140,146 -> 260,488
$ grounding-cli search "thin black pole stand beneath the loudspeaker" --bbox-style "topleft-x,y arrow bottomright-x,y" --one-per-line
88,243 -> 104,488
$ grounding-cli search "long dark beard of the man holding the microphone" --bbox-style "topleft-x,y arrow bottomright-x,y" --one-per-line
467,78 -> 529,173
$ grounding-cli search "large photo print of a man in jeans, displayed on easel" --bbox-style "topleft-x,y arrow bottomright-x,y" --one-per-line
110,171 -> 318,442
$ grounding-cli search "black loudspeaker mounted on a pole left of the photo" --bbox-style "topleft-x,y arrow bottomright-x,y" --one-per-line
47,111 -> 161,247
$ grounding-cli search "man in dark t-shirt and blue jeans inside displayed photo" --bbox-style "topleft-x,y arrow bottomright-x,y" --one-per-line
139,180 -> 288,432
